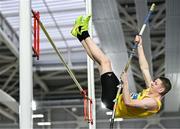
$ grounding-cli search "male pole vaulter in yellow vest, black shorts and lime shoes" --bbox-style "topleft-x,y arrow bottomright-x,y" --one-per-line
71,16 -> 171,118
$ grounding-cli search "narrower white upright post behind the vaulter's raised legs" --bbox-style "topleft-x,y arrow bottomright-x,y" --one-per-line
86,0 -> 96,129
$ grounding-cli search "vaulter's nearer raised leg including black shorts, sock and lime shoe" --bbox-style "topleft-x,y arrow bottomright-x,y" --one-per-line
71,17 -> 119,109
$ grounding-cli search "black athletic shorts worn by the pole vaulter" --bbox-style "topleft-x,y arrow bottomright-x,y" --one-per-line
101,72 -> 120,110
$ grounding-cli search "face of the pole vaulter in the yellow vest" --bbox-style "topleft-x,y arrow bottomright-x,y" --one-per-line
151,78 -> 164,93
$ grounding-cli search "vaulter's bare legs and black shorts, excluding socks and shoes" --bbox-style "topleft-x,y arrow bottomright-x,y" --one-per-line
82,37 -> 119,110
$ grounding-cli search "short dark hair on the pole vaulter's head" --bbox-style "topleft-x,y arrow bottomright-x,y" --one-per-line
159,77 -> 172,96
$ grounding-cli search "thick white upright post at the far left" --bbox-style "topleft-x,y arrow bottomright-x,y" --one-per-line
19,0 -> 33,129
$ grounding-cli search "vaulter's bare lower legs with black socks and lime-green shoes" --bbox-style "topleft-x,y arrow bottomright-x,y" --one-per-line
71,16 -> 112,75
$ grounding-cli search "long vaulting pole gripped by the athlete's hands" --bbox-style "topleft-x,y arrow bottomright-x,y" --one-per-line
110,3 -> 155,129
